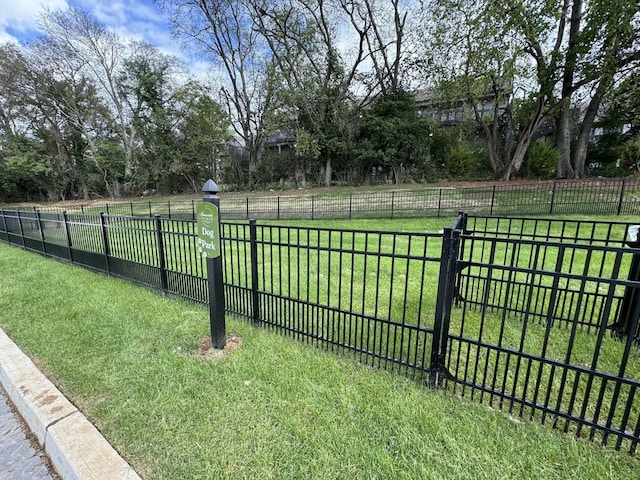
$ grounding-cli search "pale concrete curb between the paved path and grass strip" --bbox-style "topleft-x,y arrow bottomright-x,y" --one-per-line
0,329 -> 140,480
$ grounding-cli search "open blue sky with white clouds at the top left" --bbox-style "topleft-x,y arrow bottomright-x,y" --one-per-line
0,0 -> 199,70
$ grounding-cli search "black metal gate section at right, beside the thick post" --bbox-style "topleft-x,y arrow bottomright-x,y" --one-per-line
444,217 -> 640,452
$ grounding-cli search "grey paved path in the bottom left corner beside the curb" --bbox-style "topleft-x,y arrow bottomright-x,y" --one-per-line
0,386 -> 53,480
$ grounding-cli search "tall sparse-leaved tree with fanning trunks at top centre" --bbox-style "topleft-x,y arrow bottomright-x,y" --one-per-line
252,0 -> 416,186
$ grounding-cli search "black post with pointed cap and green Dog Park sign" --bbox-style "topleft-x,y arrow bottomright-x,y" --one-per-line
196,180 -> 227,349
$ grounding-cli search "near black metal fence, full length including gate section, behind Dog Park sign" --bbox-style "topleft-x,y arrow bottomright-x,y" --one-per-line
0,206 -> 640,453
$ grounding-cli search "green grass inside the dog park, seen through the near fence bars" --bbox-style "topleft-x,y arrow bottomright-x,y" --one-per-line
8,217 -> 640,394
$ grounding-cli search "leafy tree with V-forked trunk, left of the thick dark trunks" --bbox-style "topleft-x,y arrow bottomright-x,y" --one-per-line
427,0 -> 551,180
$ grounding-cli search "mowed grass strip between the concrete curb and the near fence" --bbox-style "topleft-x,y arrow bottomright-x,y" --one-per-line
0,244 -> 638,480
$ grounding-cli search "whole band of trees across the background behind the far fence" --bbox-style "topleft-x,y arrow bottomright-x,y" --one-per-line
0,0 -> 640,200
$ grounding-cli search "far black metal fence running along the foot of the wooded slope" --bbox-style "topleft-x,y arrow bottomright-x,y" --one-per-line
12,178 -> 640,220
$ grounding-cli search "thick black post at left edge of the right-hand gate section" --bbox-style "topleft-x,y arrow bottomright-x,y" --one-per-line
429,227 -> 460,387
